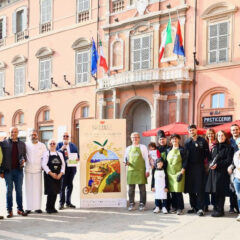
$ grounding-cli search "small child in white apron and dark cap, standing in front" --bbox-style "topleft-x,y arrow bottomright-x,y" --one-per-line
152,158 -> 168,214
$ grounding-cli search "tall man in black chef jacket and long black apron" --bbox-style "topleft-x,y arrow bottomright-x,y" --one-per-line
184,124 -> 209,216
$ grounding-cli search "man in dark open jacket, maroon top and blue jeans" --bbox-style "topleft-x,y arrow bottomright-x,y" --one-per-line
0,127 -> 27,218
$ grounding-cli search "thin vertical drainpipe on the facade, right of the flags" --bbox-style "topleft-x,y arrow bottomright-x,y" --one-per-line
192,0 -> 199,123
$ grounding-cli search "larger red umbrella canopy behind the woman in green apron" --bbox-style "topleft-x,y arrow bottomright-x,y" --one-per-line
142,122 -> 206,137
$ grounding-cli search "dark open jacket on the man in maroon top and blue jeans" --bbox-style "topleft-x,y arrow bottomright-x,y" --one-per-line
0,138 -> 27,173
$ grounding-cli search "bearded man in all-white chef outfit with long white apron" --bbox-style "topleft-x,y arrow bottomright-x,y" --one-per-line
25,130 -> 47,213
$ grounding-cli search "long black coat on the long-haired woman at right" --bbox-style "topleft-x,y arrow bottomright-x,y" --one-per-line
205,143 -> 234,196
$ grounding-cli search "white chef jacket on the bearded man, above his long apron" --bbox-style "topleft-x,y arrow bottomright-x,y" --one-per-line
25,142 -> 47,173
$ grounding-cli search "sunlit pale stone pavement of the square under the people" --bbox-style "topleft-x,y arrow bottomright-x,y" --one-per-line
0,172 -> 240,240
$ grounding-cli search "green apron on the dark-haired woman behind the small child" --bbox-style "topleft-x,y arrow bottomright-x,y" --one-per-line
167,149 -> 185,192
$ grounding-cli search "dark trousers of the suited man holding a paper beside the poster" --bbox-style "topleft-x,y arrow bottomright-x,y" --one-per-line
59,167 -> 76,205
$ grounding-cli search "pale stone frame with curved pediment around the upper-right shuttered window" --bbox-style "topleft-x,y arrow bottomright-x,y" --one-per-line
201,2 -> 237,66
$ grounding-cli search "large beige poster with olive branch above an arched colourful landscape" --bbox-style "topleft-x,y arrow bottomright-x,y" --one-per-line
79,119 -> 127,208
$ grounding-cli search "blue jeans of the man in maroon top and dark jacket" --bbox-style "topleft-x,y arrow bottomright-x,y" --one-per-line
4,169 -> 23,212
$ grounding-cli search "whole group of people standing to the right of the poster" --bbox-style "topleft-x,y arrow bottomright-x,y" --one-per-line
124,124 -> 240,221
